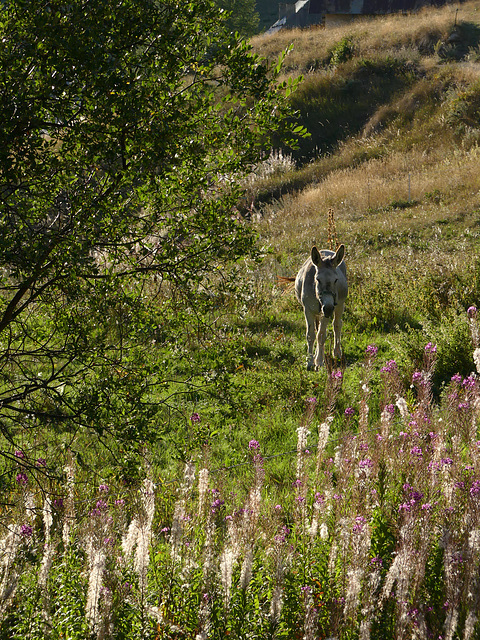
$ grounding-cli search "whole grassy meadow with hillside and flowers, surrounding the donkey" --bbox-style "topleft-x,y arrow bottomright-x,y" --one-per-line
4,2 -> 480,640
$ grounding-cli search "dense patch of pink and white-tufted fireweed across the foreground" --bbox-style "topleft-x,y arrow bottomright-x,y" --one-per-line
0,307 -> 480,640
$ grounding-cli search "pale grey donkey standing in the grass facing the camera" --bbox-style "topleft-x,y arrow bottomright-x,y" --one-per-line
295,244 -> 348,371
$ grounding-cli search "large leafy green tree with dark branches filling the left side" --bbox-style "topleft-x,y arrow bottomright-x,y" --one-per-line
0,0 -> 300,476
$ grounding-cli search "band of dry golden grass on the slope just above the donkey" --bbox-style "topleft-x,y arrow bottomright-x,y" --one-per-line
260,141 -> 480,260
